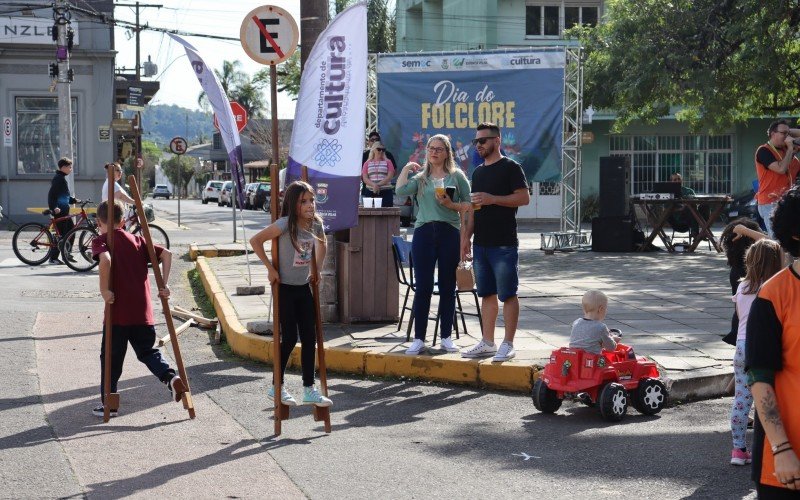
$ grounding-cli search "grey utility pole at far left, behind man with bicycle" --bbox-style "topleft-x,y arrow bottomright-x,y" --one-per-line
50,0 -> 75,196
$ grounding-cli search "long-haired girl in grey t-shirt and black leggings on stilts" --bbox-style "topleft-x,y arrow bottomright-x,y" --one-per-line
250,181 -> 332,406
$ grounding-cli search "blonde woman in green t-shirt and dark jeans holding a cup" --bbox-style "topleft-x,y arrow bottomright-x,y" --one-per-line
397,134 -> 470,355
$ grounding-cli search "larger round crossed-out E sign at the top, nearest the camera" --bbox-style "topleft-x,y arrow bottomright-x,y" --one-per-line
239,5 -> 300,64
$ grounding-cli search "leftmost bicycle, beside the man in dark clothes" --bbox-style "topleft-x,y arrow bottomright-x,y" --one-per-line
11,199 -> 95,266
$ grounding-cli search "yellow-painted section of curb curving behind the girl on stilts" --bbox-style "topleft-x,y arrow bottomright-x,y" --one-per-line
195,256 -> 538,392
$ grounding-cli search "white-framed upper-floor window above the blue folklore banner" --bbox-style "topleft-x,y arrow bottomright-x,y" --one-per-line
525,0 -> 600,37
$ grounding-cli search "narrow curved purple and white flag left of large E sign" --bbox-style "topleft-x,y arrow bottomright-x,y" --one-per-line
168,33 -> 244,207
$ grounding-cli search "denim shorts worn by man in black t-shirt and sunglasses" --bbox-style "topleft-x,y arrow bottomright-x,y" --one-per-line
472,245 -> 519,302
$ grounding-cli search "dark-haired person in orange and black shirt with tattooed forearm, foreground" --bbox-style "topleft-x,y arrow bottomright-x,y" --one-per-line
745,186 -> 800,499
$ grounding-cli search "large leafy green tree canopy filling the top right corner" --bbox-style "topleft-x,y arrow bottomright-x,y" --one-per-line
567,0 -> 800,132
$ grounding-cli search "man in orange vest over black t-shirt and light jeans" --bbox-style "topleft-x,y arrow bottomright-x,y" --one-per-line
755,120 -> 800,238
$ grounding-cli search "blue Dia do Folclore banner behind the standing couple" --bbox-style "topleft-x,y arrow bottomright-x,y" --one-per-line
378,49 -> 566,182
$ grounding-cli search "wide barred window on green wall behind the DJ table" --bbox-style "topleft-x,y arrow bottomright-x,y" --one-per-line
610,135 -> 733,194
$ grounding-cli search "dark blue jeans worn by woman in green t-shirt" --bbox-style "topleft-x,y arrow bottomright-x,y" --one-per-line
411,222 -> 461,340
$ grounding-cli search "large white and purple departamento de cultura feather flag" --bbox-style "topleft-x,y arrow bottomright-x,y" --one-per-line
286,2 -> 367,232
